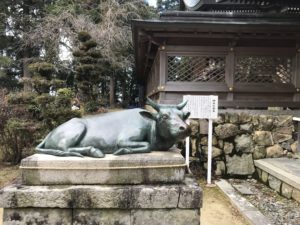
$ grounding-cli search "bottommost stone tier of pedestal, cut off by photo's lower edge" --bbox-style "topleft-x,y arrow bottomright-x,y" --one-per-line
3,208 -> 200,225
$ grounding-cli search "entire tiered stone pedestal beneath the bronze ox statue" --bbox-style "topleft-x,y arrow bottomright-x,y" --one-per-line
0,152 -> 202,225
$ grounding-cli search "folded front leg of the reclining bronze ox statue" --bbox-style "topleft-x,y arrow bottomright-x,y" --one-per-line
114,141 -> 150,155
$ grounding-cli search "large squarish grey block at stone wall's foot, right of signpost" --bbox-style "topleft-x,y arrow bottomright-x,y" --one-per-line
226,154 -> 255,175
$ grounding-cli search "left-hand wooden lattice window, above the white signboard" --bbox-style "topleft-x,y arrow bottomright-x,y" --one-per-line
167,56 -> 225,82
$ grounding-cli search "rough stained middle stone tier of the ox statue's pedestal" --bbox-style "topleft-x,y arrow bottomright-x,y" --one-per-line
0,177 -> 202,209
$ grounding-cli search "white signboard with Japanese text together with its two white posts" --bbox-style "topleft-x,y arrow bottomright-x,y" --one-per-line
183,95 -> 218,185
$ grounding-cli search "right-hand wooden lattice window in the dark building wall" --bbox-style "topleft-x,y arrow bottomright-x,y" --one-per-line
234,56 -> 292,84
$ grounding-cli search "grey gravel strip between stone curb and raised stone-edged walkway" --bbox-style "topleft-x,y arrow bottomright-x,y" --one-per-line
228,179 -> 300,225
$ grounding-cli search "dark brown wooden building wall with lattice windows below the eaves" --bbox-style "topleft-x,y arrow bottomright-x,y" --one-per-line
146,43 -> 300,108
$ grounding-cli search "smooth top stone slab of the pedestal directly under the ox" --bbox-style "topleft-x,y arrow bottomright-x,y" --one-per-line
20,151 -> 186,185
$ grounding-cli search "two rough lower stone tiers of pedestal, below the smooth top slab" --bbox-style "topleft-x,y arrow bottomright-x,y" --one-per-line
0,176 -> 202,225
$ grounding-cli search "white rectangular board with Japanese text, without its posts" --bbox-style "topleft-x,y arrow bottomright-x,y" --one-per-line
183,95 -> 218,119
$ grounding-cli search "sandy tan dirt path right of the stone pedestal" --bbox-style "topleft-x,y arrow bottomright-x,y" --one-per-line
200,180 -> 249,225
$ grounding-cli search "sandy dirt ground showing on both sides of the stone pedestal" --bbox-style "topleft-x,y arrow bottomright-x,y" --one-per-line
0,164 -> 249,225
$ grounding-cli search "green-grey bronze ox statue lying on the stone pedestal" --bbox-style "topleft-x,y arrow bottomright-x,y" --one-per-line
36,99 -> 191,158
